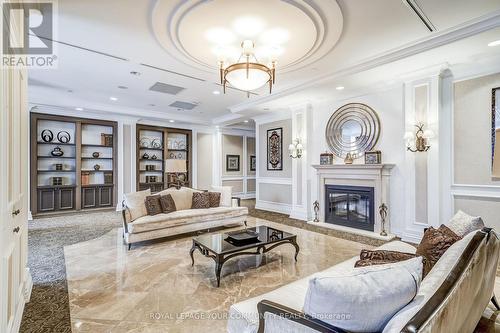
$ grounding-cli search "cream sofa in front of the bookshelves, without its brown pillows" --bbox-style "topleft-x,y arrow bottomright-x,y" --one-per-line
122,187 -> 248,249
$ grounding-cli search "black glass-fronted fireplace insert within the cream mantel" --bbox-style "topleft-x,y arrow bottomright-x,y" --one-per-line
325,185 -> 375,231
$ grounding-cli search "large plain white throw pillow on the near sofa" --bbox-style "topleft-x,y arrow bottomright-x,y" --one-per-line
304,257 -> 423,332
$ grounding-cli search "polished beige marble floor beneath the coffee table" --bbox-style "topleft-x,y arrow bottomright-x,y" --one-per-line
64,217 -> 500,333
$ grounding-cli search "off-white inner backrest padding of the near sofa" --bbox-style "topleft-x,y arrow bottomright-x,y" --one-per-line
383,232 -> 475,333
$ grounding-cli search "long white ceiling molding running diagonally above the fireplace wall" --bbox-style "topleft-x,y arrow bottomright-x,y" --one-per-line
229,10 -> 500,113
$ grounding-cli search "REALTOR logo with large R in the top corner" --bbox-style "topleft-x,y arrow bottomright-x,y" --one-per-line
2,1 -> 57,68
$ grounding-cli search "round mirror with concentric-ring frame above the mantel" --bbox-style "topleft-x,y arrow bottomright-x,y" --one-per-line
326,103 -> 380,158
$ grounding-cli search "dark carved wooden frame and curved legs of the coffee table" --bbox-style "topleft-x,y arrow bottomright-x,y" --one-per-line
189,237 -> 300,287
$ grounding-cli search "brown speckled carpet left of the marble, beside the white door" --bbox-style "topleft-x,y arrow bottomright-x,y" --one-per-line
20,212 -> 121,333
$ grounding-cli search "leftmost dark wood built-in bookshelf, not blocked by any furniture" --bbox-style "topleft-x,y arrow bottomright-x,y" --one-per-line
31,113 -> 117,215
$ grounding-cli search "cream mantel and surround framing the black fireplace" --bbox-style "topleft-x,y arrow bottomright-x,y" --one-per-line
312,164 -> 395,236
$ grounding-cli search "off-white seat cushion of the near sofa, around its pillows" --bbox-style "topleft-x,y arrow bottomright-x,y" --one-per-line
227,241 -> 416,333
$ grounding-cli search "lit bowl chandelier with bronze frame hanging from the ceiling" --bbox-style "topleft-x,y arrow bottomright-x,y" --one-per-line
219,40 -> 276,97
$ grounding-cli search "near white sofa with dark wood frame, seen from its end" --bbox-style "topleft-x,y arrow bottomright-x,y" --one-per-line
227,228 -> 500,333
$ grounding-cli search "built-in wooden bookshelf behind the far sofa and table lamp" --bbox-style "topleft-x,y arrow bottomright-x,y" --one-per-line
136,125 -> 192,193
